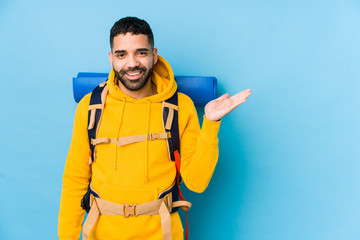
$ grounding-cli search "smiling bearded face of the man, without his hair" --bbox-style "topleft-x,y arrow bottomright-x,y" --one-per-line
109,33 -> 158,91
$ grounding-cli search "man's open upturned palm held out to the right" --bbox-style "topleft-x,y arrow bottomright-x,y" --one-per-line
205,89 -> 251,121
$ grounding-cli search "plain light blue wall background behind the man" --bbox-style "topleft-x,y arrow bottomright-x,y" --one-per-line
0,0 -> 360,240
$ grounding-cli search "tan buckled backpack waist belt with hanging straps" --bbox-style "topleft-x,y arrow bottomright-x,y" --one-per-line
83,182 -> 191,240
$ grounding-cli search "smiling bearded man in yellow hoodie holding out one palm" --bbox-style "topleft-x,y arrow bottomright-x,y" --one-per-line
59,17 -> 251,240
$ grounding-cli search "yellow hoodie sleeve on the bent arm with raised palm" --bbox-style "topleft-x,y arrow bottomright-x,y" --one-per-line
179,95 -> 220,193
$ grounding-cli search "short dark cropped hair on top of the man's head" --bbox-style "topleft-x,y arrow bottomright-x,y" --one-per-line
110,17 -> 154,49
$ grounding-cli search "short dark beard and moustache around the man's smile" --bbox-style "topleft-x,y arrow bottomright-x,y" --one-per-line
113,67 -> 153,91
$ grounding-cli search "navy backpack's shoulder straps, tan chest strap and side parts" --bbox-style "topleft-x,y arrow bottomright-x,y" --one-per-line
81,82 -> 191,239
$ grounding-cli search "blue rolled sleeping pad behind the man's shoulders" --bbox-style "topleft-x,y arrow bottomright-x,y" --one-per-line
73,72 -> 217,107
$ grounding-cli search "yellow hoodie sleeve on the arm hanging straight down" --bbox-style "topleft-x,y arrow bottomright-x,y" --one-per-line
58,95 -> 91,240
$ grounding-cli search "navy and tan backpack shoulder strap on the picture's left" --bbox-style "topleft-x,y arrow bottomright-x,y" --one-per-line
88,82 -> 108,164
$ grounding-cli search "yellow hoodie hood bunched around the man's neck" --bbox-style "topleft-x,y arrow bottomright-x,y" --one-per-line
107,56 -> 177,103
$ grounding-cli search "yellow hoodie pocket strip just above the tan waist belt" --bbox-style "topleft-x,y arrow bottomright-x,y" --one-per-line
100,184 -> 158,204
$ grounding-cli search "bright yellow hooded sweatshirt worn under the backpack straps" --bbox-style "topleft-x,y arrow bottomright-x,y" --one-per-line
58,57 -> 220,240
